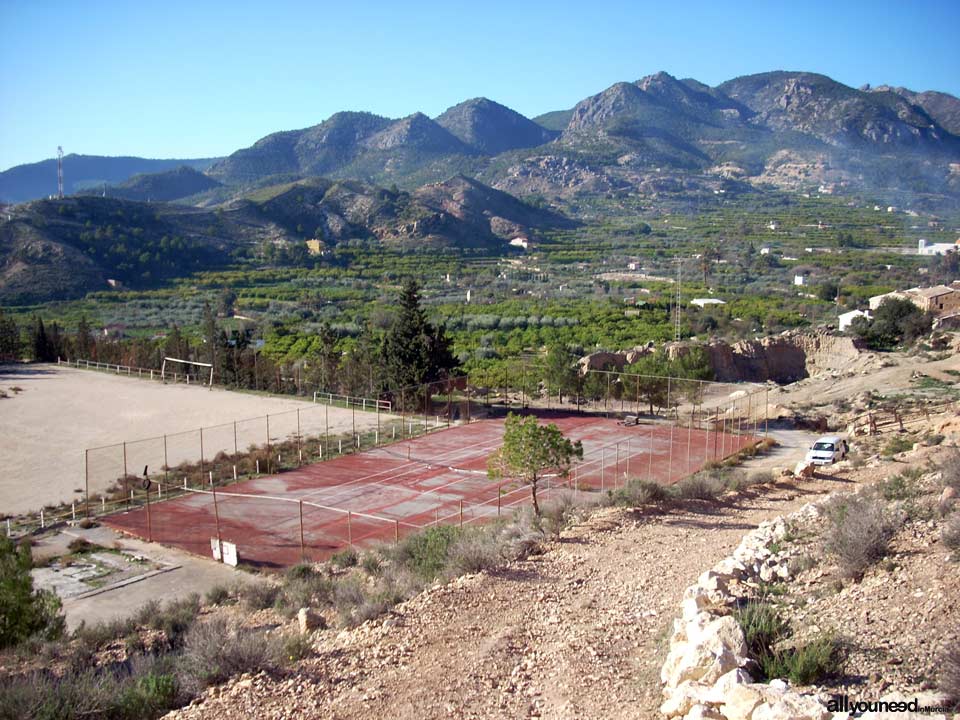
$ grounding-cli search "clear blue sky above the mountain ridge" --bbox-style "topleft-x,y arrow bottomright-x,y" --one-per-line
0,0 -> 960,169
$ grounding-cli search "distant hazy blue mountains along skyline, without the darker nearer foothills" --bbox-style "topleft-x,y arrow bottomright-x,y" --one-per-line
0,71 -> 960,203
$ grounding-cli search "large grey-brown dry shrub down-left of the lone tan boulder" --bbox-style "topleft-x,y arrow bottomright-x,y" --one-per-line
177,617 -> 282,694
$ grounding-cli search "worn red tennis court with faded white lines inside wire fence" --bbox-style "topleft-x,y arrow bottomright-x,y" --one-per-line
104,415 -> 758,567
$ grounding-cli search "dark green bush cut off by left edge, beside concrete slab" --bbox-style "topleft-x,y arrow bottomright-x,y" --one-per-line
0,537 -> 65,649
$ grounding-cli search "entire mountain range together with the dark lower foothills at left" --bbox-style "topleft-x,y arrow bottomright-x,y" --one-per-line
0,71 -> 960,302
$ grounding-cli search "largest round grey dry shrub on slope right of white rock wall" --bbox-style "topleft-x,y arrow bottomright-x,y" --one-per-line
824,495 -> 895,579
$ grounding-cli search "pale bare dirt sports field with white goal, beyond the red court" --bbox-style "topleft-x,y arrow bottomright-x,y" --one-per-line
0,365 -> 376,514
